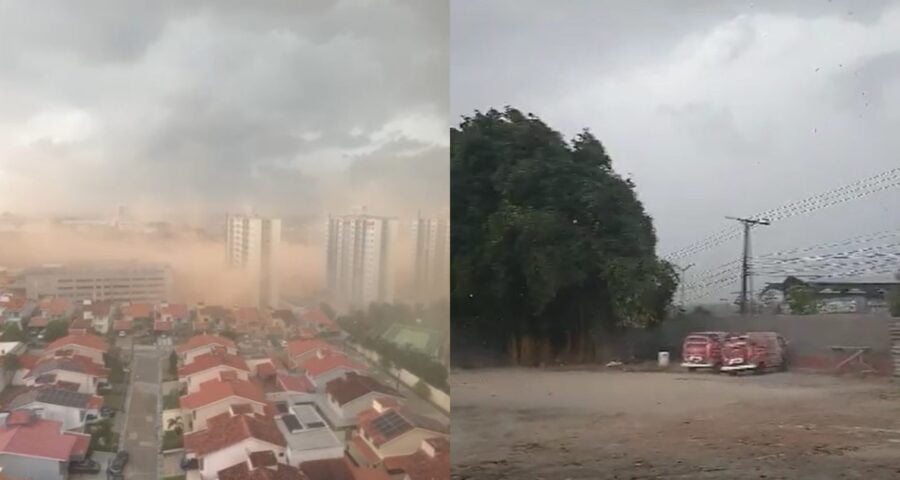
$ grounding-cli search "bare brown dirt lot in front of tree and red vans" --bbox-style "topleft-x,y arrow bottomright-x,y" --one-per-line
451,369 -> 900,480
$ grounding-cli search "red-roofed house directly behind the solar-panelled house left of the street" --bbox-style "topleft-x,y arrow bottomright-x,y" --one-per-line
24,355 -> 109,394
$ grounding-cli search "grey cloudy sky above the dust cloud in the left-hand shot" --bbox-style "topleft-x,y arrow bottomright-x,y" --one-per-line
0,0 -> 449,220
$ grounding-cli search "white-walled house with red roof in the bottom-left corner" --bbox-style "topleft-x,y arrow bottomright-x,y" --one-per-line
0,410 -> 91,480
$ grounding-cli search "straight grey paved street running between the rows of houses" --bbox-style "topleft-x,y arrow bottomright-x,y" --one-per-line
119,350 -> 161,480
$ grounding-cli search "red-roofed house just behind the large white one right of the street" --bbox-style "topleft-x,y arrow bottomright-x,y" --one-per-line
179,378 -> 267,431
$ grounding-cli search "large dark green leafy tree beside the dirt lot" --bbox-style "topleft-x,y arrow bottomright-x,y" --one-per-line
451,108 -> 677,363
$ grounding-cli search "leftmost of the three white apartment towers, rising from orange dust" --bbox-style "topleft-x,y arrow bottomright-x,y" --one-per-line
225,215 -> 281,308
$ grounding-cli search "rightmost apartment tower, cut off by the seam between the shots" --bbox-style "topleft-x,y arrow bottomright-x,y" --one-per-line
410,217 -> 450,301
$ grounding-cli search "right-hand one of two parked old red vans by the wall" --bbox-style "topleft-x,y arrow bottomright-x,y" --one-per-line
721,332 -> 787,375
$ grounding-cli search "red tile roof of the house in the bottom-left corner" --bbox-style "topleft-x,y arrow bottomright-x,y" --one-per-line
0,419 -> 83,462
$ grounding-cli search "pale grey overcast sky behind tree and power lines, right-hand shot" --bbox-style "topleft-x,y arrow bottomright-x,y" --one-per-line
450,0 -> 900,295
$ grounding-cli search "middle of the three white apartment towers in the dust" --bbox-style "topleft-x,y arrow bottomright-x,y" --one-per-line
326,214 -> 396,308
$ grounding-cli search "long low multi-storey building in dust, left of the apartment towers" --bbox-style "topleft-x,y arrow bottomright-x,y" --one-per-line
22,262 -> 172,302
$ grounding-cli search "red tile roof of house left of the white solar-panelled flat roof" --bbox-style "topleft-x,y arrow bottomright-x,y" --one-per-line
184,414 -> 285,456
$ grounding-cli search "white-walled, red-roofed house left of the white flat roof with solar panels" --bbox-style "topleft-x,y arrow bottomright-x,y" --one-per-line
184,411 -> 287,480
